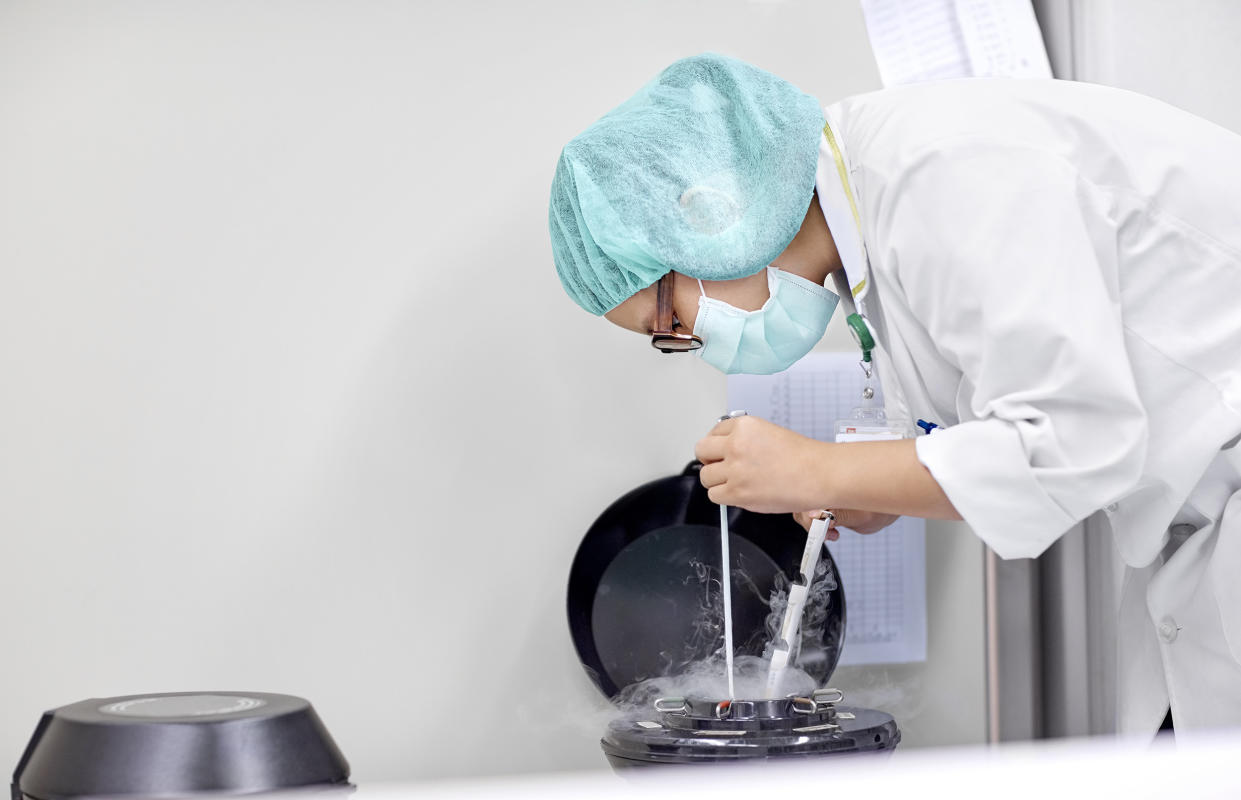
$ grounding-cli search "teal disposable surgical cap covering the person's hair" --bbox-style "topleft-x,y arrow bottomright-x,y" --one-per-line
549,53 -> 823,314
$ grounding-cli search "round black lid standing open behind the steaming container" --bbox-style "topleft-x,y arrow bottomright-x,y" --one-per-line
568,463 -> 845,697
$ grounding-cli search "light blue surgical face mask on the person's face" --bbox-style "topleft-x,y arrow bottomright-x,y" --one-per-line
694,267 -> 839,375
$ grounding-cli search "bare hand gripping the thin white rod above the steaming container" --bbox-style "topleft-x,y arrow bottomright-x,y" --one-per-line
694,417 -> 830,513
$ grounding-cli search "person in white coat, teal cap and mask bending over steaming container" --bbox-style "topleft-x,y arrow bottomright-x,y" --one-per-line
550,55 -> 1241,732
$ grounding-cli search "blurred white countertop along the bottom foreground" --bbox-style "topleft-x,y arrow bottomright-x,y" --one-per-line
355,731 -> 1241,800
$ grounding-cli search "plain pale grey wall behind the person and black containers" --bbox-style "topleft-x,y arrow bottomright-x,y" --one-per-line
0,0 -> 982,781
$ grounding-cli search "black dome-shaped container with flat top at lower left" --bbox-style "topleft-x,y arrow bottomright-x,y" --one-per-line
12,692 -> 349,800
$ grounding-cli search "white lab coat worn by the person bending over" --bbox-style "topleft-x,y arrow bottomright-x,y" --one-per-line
817,79 -> 1241,733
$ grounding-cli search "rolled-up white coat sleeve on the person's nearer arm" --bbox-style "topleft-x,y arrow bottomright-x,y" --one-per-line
877,143 -> 1147,558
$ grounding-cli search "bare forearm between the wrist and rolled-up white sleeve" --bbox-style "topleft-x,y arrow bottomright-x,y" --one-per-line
810,439 -> 961,520
